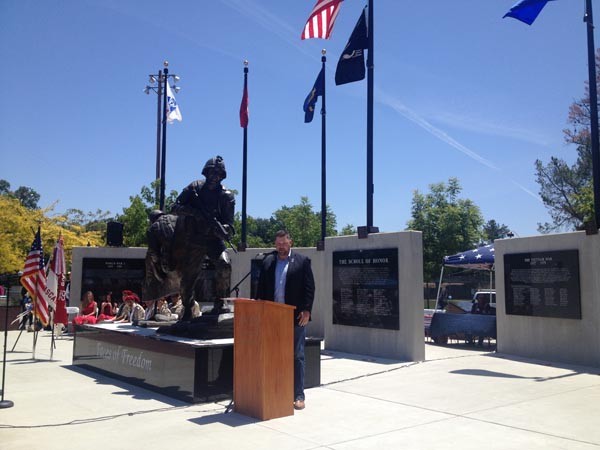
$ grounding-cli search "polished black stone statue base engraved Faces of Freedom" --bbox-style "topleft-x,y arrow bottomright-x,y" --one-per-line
73,325 -> 321,403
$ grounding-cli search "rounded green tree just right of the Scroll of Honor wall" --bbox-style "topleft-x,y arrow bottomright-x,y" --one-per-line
408,178 -> 483,281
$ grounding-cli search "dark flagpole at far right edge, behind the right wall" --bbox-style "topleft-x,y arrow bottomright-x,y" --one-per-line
583,0 -> 600,230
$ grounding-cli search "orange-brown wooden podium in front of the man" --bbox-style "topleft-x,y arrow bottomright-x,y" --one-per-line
233,299 -> 295,420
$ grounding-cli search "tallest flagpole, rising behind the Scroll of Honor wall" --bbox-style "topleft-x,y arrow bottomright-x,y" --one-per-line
366,0 -> 379,234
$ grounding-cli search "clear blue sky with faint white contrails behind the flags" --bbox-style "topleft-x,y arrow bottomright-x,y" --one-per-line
0,0 -> 600,236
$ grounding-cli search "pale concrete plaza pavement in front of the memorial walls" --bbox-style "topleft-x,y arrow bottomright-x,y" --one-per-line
0,331 -> 600,450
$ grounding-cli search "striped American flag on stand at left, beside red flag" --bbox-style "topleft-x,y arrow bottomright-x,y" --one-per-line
21,227 -> 49,325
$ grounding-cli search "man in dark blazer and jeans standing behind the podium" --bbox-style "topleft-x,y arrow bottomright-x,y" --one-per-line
256,230 -> 315,409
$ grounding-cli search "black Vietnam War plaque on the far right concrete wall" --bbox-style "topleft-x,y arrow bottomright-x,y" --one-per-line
504,250 -> 581,319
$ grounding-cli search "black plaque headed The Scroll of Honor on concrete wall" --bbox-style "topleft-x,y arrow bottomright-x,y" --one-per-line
333,248 -> 400,330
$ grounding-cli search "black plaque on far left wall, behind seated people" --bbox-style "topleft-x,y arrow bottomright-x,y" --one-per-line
81,258 -> 146,301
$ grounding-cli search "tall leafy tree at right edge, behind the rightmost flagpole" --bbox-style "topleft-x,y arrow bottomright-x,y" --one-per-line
535,50 -> 600,233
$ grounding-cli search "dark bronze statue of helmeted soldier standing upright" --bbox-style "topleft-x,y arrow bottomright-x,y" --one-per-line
171,156 -> 235,321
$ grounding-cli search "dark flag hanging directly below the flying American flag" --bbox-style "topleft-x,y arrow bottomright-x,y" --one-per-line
335,8 -> 369,86
